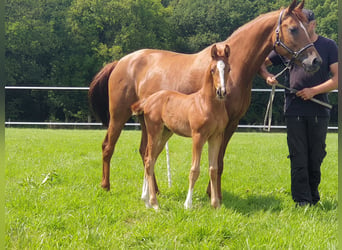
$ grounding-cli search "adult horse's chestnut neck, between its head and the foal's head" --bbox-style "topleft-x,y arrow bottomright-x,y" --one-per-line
224,11 -> 279,88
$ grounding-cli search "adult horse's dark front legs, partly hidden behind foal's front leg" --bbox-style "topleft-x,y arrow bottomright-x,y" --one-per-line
207,121 -> 239,201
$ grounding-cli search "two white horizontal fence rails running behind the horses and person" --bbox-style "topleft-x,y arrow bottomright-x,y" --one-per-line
5,86 -> 338,131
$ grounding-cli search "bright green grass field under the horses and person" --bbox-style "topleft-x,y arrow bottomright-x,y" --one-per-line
5,128 -> 338,249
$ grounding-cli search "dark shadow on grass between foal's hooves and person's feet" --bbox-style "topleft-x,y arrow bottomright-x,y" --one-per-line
222,191 -> 283,214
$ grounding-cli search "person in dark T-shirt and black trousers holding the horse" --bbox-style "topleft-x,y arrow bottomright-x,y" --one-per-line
259,9 -> 338,206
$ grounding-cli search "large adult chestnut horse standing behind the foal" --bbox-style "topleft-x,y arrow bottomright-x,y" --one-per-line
89,0 -> 322,202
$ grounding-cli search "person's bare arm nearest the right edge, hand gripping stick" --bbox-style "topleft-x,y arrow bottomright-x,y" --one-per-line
296,63 -> 338,100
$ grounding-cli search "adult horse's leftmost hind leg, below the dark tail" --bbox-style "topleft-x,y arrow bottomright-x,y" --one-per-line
101,112 -> 131,191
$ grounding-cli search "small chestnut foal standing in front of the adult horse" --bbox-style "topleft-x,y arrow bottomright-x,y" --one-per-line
131,45 -> 230,209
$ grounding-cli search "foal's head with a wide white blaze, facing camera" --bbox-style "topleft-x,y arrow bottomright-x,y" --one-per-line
210,44 -> 230,99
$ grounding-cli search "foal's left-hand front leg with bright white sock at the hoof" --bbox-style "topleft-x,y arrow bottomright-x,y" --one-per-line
184,134 -> 205,209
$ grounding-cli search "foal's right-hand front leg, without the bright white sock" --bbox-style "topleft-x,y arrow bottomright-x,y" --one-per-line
208,133 -> 223,208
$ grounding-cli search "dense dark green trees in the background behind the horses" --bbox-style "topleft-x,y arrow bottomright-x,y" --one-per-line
5,0 -> 338,124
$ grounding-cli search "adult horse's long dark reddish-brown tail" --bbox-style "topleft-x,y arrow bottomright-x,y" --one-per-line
88,61 -> 118,127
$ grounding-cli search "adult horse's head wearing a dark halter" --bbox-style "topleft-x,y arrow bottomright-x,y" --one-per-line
273,0 -> 322,72
